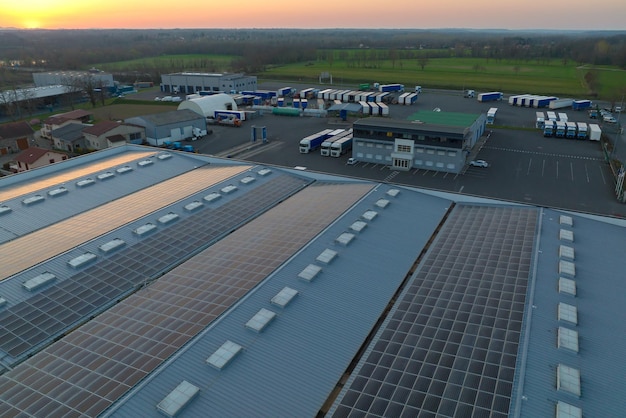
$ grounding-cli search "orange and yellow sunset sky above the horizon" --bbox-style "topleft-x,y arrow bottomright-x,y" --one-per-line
0,0 -> 626,30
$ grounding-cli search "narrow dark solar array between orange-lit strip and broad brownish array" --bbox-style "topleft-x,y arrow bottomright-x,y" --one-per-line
0,171 -> 305,363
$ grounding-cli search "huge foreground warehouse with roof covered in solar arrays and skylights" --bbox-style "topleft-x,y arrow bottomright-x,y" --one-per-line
0,145 -> 626,418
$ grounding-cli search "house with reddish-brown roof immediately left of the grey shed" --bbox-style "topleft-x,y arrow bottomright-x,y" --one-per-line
83,121 -> 146,150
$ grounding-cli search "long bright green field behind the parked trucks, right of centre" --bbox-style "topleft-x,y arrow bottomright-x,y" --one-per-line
260,58 -> 626,100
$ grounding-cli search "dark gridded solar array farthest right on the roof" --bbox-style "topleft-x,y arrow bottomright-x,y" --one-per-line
331,205 -> 538,418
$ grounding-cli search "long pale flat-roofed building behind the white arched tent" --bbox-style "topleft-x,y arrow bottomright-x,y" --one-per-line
161,72 -> 257,94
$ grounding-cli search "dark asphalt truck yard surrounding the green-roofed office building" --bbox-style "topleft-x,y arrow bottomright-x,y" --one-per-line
152,85 -> 626,217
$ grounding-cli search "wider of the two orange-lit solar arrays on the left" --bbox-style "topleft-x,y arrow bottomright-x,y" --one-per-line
0,166 -> 248,280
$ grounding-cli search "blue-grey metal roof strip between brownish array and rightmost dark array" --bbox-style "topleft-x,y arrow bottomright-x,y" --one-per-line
105,186 -> 450,416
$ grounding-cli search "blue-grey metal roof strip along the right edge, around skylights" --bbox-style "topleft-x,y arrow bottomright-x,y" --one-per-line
512,209 -> 626,418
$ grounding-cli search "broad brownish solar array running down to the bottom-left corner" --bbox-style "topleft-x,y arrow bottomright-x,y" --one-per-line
0,184 -> 372,416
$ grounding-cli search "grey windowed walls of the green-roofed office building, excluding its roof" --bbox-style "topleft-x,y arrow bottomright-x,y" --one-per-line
352,115 -> 486,173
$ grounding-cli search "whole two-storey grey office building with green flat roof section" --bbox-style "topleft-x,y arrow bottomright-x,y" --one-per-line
352,112 -> 486,173
